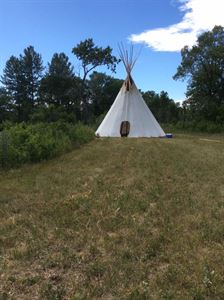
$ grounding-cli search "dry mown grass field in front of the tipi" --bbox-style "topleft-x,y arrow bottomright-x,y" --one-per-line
0,135 -> 224,300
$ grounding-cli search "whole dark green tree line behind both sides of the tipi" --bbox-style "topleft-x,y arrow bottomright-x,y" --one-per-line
0,26 -> 224,130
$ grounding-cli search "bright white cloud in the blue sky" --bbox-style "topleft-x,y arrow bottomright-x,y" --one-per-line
129,0 -> 224,52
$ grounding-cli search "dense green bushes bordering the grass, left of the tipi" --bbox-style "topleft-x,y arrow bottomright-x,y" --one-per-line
0,122 -> 94,167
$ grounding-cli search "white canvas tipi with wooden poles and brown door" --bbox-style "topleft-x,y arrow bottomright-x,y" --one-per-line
96,46 -> 165,137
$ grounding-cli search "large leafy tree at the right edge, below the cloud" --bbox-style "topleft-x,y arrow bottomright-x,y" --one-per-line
174,26 -> 224,122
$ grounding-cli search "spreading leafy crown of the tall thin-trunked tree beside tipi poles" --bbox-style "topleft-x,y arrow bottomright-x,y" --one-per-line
72,39 -> 120,81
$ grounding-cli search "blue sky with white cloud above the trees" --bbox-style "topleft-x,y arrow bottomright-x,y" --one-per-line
0,0 -> 224,101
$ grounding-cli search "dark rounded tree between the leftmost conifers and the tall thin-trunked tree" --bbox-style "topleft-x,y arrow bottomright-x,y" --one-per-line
39,53 -> 83,120
